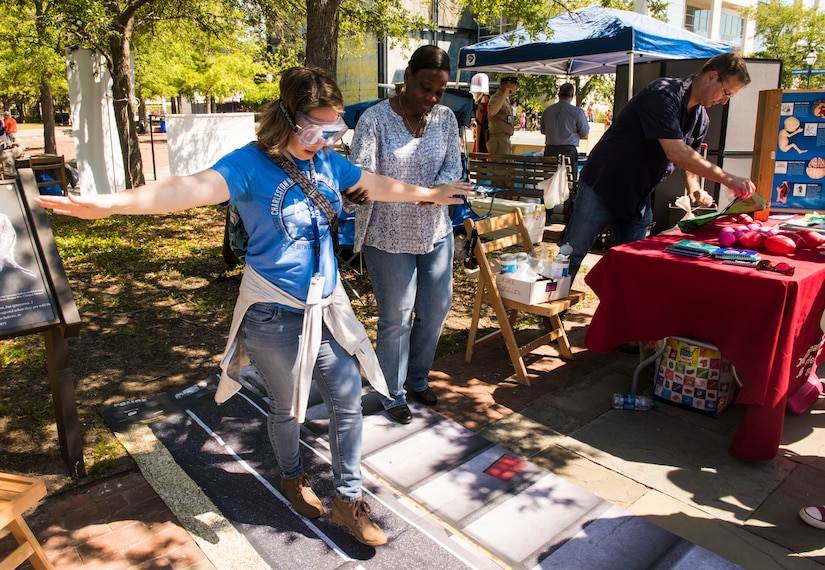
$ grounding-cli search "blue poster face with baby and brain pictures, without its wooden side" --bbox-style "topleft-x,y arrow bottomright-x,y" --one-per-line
771,91 -> 825,212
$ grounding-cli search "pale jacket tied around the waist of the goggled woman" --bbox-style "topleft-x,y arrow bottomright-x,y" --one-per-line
215,265 -> 390,423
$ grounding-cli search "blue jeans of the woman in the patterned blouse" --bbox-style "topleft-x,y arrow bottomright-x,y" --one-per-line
364,235 -> 453,410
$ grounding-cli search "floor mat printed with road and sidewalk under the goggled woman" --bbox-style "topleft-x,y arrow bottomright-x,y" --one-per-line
90,369 -> 738,570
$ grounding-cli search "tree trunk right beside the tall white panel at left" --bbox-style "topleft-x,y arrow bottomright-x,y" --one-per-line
109,21 -> 146,188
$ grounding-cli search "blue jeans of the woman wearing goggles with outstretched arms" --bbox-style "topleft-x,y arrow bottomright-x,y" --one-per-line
239,303 -> 362,496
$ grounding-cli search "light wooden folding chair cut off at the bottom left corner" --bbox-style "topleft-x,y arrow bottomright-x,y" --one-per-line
0,473 -> 53,570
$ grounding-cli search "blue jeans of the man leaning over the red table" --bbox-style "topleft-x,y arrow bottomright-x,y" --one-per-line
564,180 -> 653,281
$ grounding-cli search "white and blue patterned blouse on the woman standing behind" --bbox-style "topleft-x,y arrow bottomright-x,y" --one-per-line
350,100 -> 462,255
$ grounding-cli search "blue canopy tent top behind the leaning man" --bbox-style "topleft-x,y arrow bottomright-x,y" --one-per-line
458,6 -> 730,96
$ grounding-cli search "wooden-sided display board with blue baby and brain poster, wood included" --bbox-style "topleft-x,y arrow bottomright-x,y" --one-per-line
751,89 -> 825,220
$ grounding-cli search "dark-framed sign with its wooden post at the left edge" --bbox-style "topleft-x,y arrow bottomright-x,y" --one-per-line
0,168 -> 86,477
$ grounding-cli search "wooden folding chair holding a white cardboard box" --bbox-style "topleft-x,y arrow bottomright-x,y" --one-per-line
464,209 -> 584,386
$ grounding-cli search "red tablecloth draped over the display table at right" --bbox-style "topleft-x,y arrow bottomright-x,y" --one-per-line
585,222 -> 825,461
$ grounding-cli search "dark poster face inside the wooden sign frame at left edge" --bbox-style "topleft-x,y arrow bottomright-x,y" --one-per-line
0,180 -> 60,338
